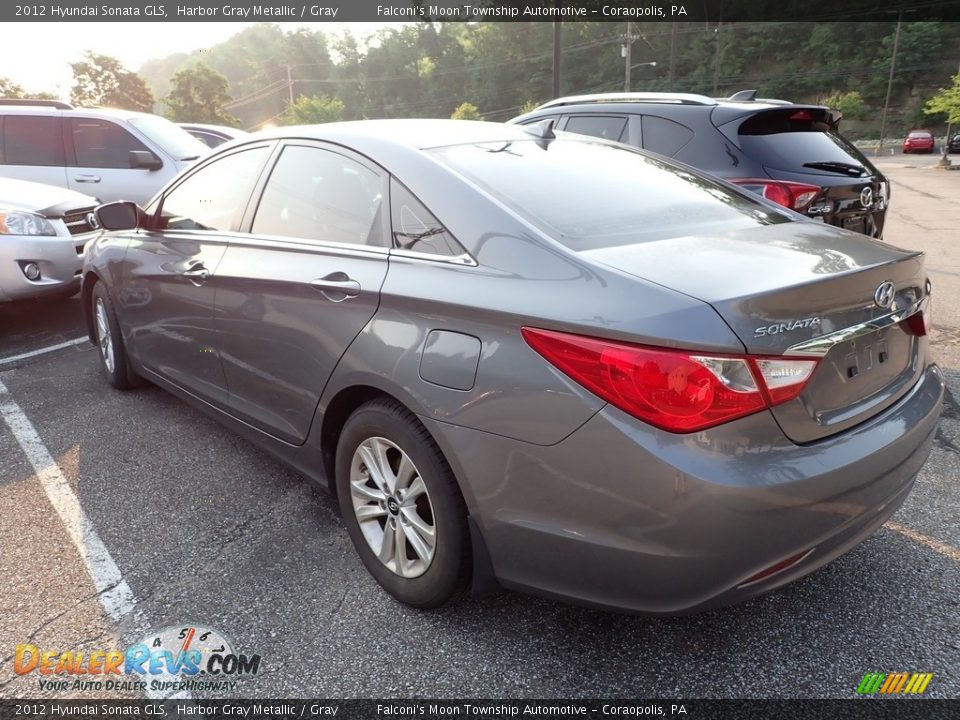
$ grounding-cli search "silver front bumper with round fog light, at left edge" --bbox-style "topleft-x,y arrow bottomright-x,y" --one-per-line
0,235 -> 83,301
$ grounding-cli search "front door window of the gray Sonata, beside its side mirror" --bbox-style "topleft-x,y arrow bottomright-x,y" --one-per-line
161,147 -> 269,230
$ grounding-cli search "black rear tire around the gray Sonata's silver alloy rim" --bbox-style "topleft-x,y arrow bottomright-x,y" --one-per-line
335,398 -> 471,609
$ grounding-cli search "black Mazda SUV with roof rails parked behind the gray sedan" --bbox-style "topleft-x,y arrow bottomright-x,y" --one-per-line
510,90 -> 890,238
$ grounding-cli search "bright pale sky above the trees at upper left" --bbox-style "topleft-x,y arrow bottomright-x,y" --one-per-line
0,22 -> 385,100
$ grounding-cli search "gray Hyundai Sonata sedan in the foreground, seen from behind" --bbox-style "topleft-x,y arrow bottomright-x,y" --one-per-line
82,120 -> 944,614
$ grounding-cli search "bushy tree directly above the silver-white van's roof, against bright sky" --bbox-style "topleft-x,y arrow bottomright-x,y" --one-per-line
70,50 -> 154,112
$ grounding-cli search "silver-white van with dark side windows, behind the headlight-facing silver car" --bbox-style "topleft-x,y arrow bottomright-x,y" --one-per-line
0,99 -> 209,204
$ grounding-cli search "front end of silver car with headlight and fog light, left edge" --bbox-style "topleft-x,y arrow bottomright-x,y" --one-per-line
0,178 -> 97,302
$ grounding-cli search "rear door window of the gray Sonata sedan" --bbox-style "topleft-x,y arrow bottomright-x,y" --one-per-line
252,145 -> 383,245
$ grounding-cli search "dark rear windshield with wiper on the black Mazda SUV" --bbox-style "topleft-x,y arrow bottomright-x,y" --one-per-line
739,109 -> 876,174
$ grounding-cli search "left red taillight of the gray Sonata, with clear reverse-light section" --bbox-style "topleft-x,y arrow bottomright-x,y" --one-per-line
522,328 -> 817,432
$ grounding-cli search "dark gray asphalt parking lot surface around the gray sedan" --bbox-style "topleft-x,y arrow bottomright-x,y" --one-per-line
0,160 -> 960,699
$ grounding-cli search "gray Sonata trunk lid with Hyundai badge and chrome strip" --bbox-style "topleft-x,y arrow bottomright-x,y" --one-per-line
584,222 -> 927,443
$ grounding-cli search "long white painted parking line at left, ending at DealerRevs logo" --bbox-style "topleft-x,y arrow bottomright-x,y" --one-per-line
0,381 -> 136,621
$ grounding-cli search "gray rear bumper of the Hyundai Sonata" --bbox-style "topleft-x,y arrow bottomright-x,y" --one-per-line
425,366 -> 944,614
